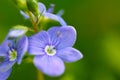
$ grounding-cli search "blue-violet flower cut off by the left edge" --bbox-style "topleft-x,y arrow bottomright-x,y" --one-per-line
0,36 -> 28,80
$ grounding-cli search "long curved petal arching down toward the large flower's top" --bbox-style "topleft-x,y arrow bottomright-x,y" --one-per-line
44,12 -> 67,26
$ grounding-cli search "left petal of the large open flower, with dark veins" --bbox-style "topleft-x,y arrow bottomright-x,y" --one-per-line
28,31 -> 50,55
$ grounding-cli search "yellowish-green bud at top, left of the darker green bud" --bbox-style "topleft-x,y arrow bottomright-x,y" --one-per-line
13,0 -> 27,11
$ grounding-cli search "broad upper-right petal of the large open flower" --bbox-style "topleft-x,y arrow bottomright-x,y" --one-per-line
48,26 -> 76,49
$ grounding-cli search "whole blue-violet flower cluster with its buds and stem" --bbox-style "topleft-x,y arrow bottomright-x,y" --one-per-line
0,0 -> 83,80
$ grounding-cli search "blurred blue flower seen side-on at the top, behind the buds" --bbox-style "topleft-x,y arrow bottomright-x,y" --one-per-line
20,2 -> 67,26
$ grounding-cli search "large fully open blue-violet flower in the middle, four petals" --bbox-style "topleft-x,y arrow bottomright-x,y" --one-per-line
28,26 -> 83,76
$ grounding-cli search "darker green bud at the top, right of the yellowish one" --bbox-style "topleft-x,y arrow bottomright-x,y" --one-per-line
27,0 -> 39,16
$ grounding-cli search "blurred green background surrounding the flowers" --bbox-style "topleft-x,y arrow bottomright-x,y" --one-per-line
0,0 -> 120,80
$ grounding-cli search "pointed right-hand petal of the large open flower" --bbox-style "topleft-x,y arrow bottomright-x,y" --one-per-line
57,47 -> 83,62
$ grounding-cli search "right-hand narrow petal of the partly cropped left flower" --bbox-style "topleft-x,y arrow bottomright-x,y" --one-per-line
16,36 -> 28,64
